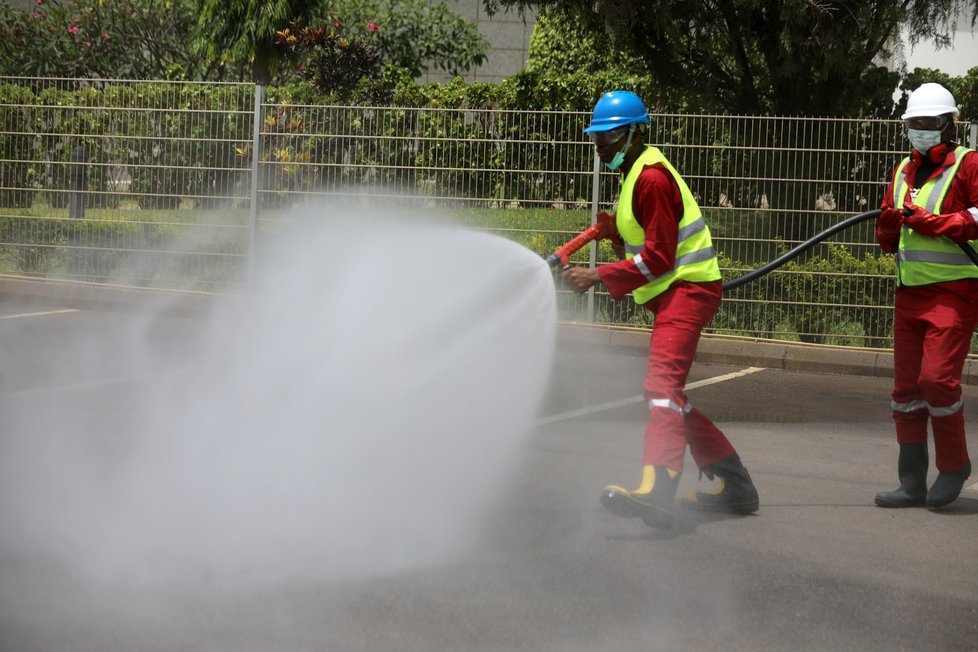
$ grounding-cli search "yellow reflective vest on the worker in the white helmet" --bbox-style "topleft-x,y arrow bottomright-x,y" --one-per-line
891,146 -> 978,286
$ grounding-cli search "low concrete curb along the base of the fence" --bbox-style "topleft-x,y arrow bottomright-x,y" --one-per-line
558,322 -> 978,385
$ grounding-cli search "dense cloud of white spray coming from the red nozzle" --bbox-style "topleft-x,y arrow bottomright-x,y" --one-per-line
0,210 -> 555,600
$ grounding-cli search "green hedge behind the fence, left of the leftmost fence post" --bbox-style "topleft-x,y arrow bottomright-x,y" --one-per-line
0,83 -> 254,208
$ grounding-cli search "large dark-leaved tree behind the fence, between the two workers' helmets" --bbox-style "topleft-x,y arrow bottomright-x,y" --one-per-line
483,0 -> 978,116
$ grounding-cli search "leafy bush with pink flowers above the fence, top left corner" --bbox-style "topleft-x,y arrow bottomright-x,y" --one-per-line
0,0 -> 207,79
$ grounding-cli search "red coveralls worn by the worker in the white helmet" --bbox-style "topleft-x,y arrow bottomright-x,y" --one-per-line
876,148 -> 978,473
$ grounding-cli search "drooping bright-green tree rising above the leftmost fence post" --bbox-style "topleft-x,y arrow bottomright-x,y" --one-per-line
192,0 -> 322,84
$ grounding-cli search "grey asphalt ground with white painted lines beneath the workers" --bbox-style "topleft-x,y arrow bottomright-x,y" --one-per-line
0,298 -> 978,652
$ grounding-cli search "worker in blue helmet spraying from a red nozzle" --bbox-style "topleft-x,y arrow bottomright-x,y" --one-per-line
563,91 -> 758,528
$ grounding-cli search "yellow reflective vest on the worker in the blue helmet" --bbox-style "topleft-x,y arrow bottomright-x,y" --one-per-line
615,146 -> 721,304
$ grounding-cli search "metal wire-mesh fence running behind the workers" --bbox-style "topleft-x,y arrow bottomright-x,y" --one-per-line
0,78 -> 978,346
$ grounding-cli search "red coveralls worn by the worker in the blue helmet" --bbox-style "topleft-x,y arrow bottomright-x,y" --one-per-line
598,165 -> 735,471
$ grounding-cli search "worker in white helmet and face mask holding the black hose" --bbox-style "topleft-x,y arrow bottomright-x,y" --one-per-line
876,83 -> 978,508
